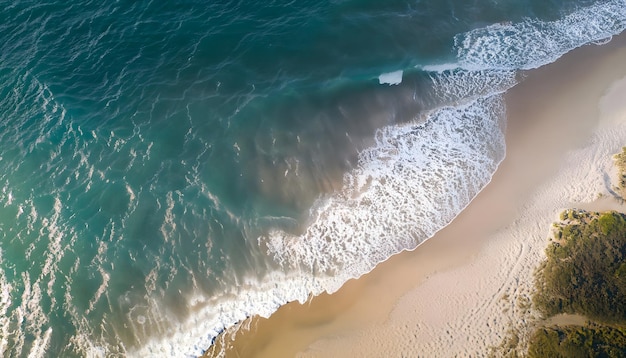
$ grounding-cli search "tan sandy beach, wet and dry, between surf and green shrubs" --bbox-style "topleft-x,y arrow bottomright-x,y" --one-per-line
207,35 -> 626,357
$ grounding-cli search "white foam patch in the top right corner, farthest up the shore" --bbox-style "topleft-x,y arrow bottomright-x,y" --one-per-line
454,0 -> 626,70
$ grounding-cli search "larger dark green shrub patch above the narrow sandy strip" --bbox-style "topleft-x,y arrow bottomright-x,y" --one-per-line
534,210 -> 626,323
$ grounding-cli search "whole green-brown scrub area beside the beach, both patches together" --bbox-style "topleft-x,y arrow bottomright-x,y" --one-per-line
492,209 -> 626,357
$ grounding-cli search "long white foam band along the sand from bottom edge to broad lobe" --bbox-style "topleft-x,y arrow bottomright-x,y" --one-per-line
129,94 -> 504,356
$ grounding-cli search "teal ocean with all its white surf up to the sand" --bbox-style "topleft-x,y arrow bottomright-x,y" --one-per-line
0,0 -> 626,357
